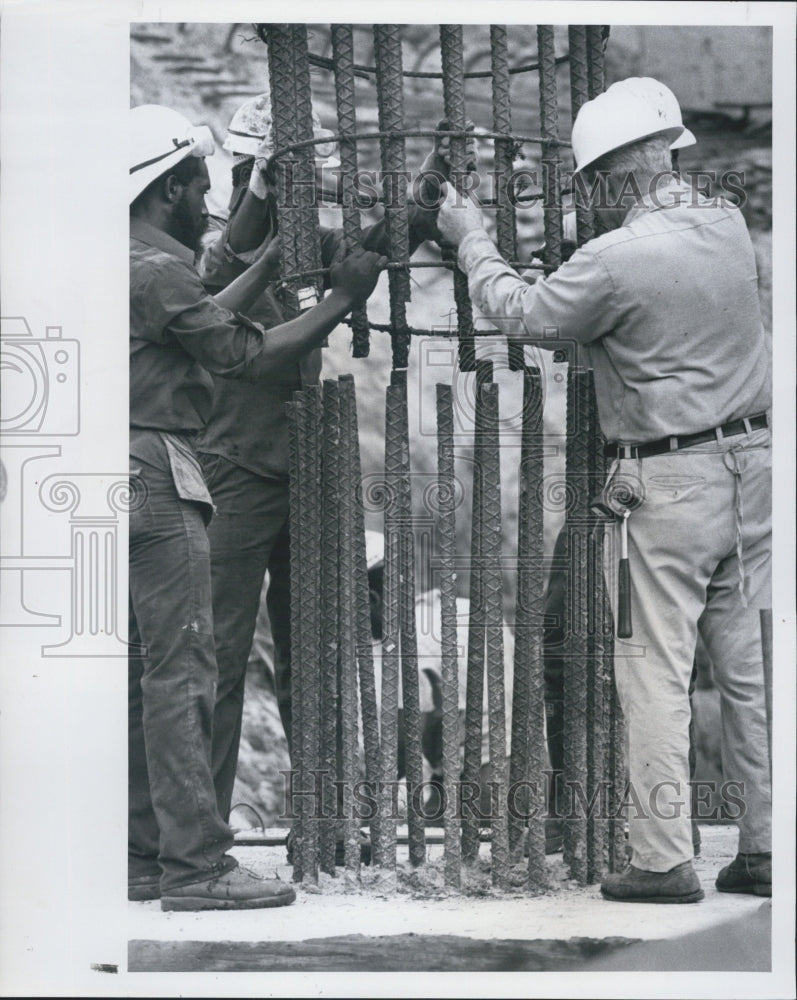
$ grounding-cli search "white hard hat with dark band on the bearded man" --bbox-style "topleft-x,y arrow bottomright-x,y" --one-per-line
129,104 -> 216,204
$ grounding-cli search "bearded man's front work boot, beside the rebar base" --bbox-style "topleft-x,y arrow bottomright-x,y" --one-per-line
161,865 -> 296,910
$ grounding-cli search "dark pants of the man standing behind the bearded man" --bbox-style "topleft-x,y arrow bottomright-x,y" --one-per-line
200,454 -> 291,819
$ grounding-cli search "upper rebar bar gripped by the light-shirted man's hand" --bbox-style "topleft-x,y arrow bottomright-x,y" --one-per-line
440,24 -> 473,371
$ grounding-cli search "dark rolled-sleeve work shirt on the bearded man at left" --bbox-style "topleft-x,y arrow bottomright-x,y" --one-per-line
130,220 -> 265,434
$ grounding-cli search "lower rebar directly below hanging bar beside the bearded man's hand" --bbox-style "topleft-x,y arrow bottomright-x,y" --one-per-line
379,385 -> 402,881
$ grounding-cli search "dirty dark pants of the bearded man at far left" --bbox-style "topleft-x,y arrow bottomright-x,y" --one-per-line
128,459 -> 235,890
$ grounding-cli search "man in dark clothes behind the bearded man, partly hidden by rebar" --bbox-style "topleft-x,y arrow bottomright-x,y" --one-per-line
198,94 -> 473,848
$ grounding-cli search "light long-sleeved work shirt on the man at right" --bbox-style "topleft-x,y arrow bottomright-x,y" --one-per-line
459,182 -> 772,444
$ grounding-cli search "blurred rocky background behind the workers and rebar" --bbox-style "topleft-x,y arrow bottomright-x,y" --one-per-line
130,23 -> 772,827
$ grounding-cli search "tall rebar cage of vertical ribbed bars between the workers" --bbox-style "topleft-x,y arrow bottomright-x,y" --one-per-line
268,24 -> 625,892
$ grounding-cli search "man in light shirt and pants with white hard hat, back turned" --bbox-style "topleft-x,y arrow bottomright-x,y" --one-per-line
438,82 -> 771,903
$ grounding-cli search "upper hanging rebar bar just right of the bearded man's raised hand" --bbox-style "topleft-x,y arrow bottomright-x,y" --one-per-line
374,24 -> 410,369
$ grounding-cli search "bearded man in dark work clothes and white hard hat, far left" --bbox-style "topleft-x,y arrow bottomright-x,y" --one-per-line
128,105 -> 386,910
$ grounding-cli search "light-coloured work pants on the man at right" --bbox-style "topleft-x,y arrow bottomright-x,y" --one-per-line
608,429 -> 772,872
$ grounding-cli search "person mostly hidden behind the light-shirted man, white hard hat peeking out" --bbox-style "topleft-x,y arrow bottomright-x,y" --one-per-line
540,77 -> 700,855
